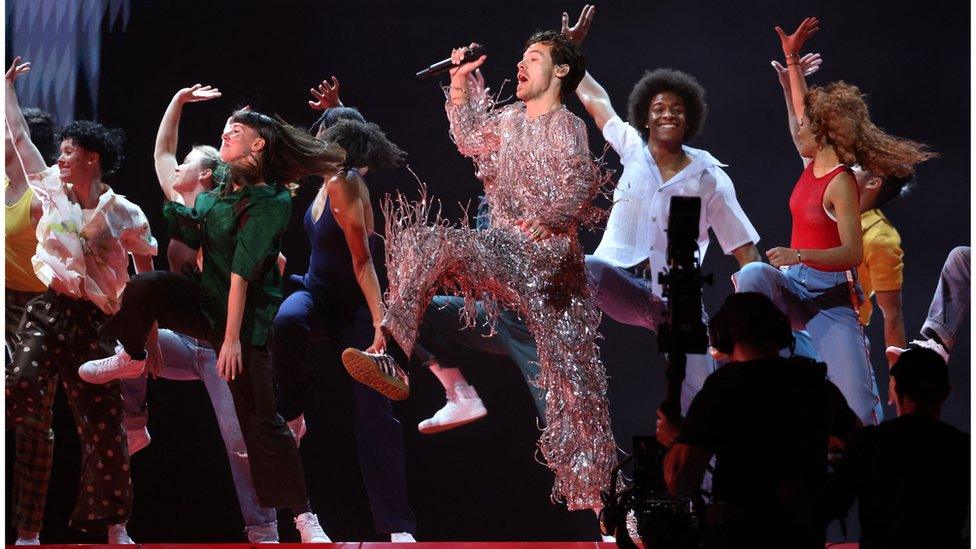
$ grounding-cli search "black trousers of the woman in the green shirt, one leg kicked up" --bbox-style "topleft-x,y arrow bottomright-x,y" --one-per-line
101,271 -> 308,507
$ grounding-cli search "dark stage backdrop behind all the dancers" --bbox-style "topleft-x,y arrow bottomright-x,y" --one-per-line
7,0 -> 970,542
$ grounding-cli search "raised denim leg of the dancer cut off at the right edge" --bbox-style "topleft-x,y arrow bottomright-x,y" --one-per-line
922,246 -> 972,351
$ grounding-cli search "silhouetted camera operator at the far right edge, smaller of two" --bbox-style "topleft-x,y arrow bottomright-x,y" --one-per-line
831,348 -> 970,549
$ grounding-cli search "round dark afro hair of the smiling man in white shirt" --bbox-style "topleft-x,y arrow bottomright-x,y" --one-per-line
627,69 -> 708,141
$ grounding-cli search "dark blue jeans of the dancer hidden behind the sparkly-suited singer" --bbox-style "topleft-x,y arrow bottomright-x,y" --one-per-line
415,295 -> 546,421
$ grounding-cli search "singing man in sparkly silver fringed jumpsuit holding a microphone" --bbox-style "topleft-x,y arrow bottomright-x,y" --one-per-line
346,31 -> 616,509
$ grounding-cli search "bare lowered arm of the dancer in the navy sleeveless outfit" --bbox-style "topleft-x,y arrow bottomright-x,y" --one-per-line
323,174 -> 386,353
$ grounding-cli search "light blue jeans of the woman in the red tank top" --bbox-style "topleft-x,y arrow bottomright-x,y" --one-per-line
732,262 -> 884,425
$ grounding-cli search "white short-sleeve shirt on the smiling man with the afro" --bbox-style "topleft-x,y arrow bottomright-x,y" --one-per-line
593,116 -> 759,295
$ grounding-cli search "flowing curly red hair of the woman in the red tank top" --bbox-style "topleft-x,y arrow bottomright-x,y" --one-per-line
803,81 -> 938,178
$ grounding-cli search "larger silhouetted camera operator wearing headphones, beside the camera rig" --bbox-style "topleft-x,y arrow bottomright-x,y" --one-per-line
658,292 -> 859,549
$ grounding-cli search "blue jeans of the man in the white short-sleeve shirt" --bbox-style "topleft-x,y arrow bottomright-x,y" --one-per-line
586,255 -> 716,414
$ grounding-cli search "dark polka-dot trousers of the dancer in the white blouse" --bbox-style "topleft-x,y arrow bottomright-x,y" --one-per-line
6,290 -> 132,534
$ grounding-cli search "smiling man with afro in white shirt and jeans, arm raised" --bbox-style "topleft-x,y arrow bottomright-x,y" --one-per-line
562,6 -> 760,410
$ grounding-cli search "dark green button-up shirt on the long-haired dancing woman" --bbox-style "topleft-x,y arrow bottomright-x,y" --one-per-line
163,183 -> 291,346
